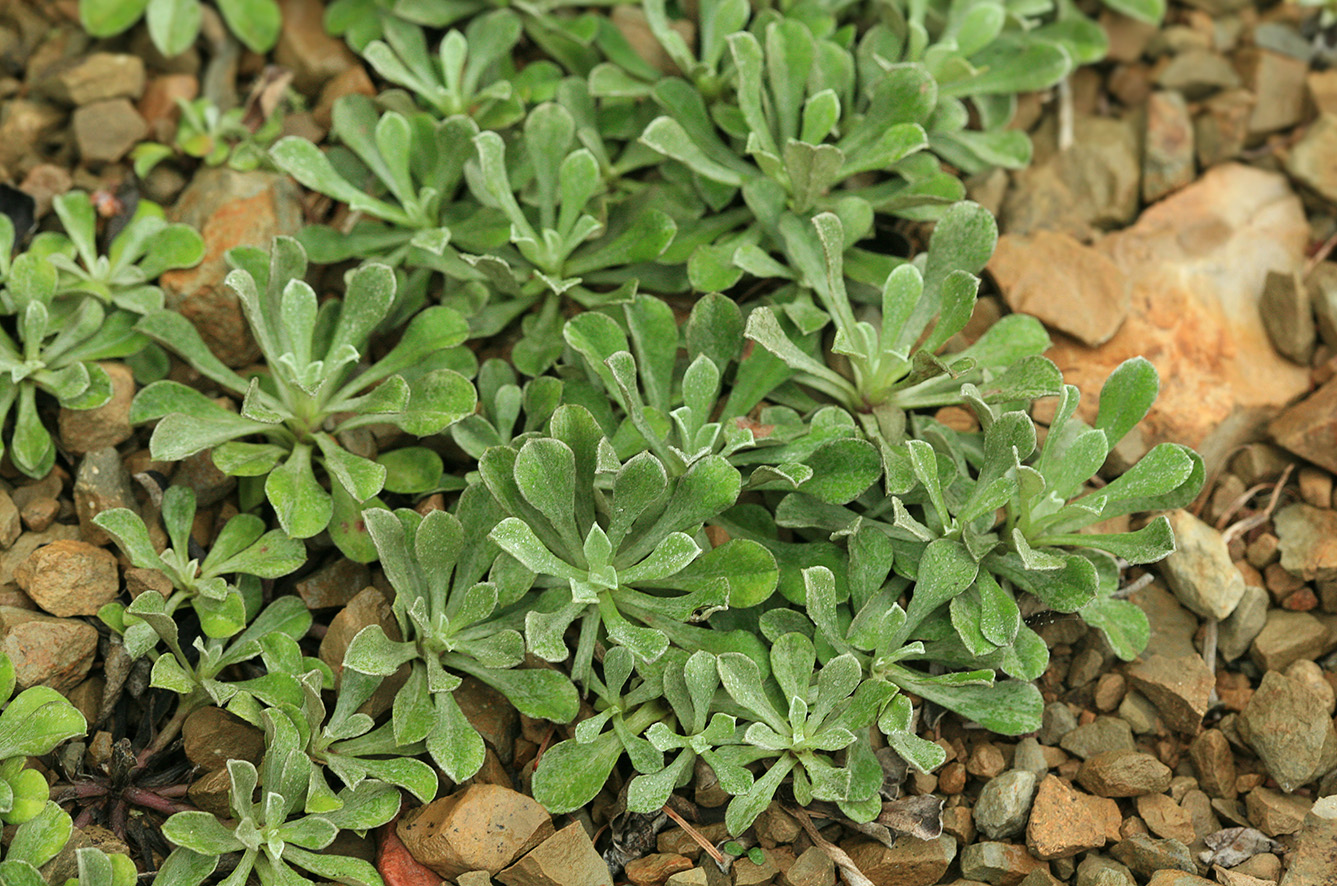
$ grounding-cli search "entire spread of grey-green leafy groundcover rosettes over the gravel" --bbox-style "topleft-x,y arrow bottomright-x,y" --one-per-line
0,0 -> 1203,886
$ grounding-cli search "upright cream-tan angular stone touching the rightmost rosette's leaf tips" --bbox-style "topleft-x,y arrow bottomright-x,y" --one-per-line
1159,510 -> 1245,619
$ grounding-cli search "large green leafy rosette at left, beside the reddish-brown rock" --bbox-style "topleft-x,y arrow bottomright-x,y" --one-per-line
131,238 -> 476,561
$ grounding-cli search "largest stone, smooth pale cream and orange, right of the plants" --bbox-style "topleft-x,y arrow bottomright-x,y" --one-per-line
1048,163 -> 1309,474
